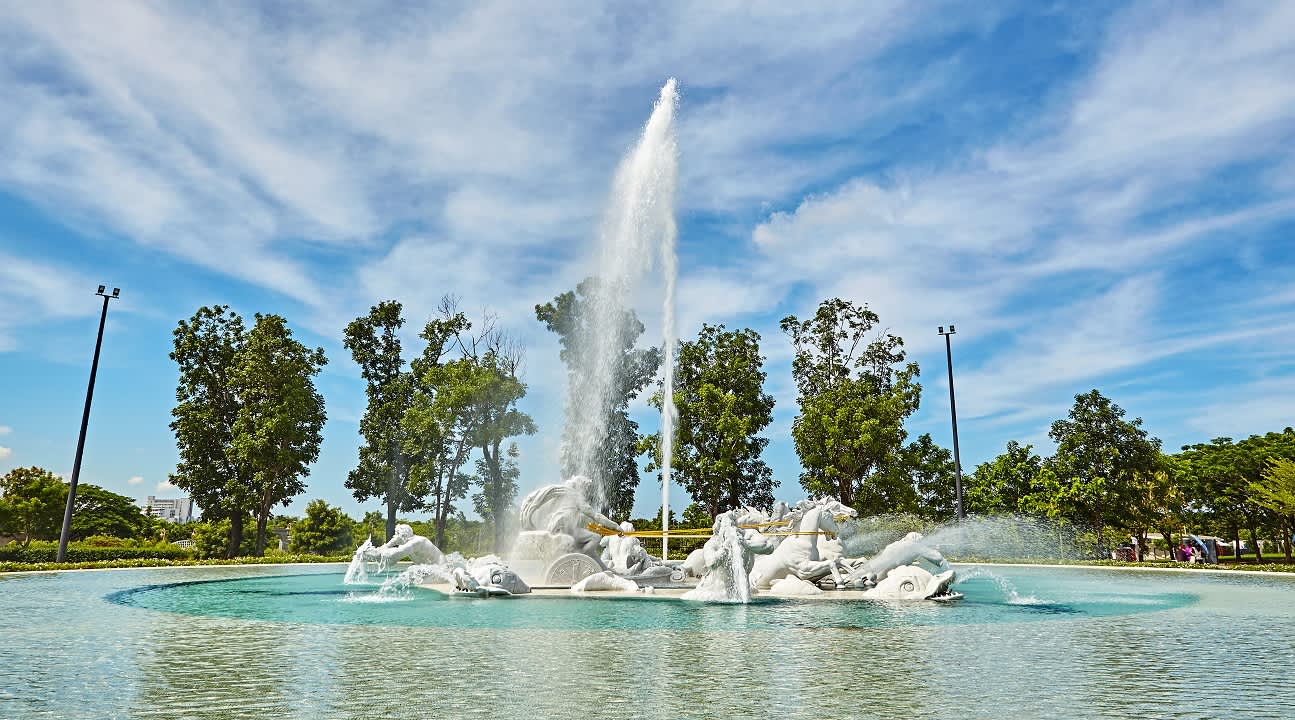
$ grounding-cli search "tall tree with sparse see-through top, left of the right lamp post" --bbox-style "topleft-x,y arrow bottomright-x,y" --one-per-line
781,298 -> 922,513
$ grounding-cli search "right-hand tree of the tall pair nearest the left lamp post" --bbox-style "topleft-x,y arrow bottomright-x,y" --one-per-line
229,313 -> 328,556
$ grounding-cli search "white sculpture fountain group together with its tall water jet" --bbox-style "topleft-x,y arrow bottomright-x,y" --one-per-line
347,78 -> 956,603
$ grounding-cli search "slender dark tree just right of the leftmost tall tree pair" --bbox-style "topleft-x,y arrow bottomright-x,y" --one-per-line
343,300 -> 426,537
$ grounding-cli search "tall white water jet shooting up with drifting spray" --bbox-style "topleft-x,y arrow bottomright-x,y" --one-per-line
566,78 -> 679,546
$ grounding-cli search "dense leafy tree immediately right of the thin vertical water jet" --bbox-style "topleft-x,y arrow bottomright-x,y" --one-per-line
642,325 -> 773,518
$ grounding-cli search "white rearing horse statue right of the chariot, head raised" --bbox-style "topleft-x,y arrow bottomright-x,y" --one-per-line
751,497 -> 859,589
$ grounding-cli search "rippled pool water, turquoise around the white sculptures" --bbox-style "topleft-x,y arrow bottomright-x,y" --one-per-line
0,566 -> 1295,719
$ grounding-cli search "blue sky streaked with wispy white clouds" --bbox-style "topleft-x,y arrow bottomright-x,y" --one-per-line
0,0 -> 1295,517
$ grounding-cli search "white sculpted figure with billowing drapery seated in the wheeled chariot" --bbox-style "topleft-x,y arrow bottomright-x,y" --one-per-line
514,475 -> 619,559
